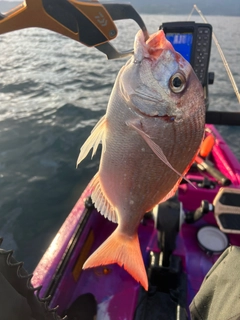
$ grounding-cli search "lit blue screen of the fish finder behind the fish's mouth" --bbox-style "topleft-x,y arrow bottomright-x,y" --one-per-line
166,33 -> 193,62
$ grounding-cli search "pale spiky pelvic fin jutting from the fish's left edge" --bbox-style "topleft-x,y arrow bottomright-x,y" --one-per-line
77,115 -> 107,166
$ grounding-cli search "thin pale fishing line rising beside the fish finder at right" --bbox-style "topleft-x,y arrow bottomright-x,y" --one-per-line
187,4 -> 240,103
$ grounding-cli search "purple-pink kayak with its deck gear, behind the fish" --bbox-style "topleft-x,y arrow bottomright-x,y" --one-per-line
32,125 -> 240,319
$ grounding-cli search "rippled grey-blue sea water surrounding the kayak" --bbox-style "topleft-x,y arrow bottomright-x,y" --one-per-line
0,15 -> 240,272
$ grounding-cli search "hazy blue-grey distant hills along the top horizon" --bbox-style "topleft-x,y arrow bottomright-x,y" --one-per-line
0,0 -> 240,16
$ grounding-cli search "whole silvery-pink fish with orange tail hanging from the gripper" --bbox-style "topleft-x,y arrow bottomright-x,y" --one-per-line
77,30 -> 205,290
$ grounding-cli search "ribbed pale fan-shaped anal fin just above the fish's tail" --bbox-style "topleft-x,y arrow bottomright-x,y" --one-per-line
91,173 -> 118,223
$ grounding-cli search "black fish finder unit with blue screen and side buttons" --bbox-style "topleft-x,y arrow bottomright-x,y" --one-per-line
159,21 -> 212,87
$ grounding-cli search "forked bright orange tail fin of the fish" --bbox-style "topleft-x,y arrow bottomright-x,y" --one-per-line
83,228 -> 148,290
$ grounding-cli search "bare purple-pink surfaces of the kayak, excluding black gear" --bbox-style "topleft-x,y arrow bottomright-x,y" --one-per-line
32,125 -> 240,319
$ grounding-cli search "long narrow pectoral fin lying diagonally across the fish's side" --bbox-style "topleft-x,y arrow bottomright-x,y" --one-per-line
126,121 -> 196,188
